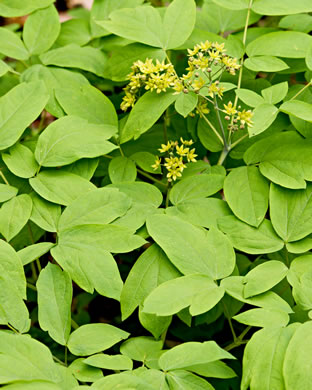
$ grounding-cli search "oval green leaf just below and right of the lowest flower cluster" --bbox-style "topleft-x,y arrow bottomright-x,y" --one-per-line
169,173 -> 224,205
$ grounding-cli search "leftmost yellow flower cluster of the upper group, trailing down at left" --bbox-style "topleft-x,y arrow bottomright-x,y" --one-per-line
120,58 -> 178,111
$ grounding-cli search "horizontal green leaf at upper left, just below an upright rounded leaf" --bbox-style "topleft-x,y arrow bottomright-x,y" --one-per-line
40,43 -> 107,77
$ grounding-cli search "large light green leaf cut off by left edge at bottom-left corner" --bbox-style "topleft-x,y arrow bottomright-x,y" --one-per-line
0,331 -> 61,383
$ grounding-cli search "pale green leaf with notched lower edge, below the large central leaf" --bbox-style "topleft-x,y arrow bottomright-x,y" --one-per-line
143,275 -> 224,316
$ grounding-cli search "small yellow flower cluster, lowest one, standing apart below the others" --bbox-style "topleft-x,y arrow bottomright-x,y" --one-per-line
152,138 -> 197,182
